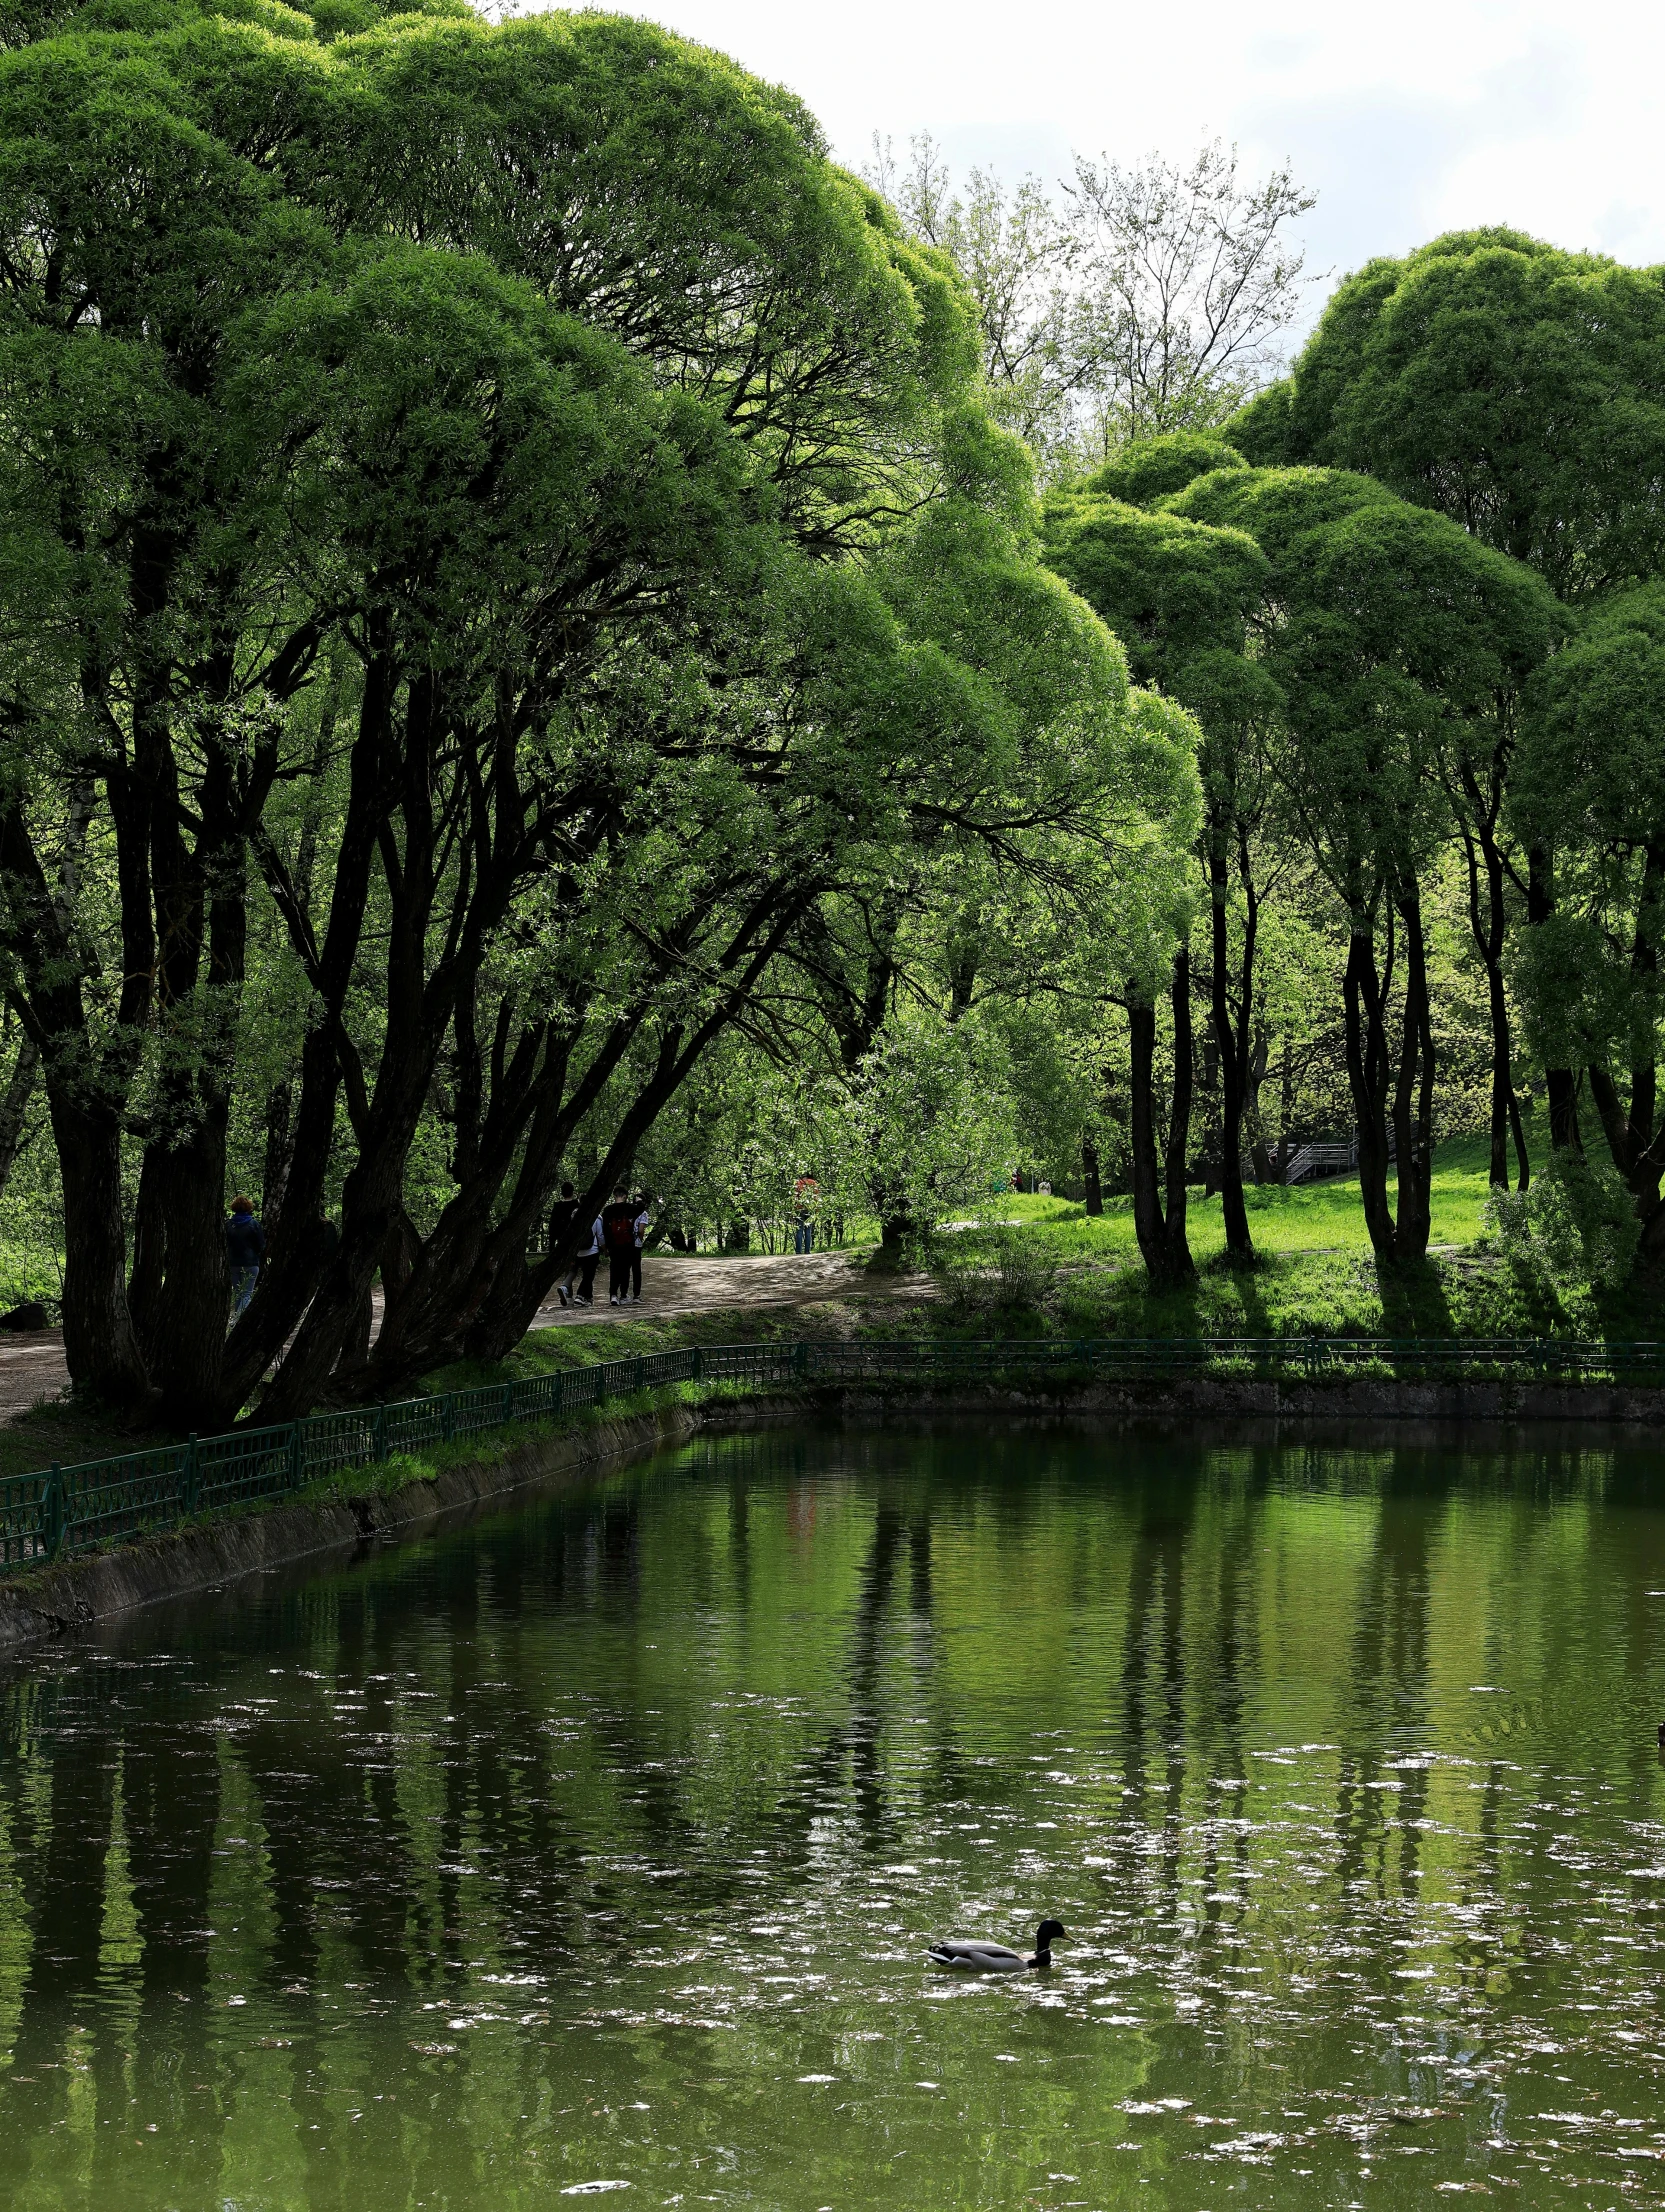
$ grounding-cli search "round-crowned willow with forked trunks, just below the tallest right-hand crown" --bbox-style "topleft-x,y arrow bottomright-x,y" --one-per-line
1170,469 -> 1557,1259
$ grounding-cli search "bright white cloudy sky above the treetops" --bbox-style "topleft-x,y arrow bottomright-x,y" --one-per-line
579,0 -> 1665,327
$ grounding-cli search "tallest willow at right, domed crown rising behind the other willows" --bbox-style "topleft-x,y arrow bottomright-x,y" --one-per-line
1232,228 -> 1665,1186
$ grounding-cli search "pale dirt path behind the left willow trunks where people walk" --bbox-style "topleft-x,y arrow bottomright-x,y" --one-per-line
0,1252 -> 929,1422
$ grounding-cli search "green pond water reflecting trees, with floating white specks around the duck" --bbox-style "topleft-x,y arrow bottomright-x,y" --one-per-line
0,1425 -> 1665,2212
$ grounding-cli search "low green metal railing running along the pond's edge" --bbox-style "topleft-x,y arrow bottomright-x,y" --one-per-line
0,1336 -> 1665,1573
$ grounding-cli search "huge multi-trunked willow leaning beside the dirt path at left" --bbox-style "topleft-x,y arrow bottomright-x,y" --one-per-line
0,7 -> 1167,1425
